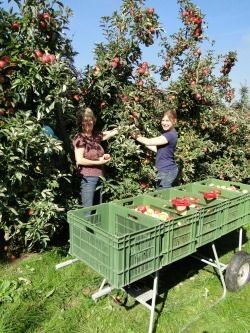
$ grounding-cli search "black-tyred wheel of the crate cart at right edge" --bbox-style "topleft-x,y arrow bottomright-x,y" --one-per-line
225,251 -> 250,291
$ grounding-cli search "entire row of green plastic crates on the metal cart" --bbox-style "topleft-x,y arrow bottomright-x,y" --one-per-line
68,179 -> 250,288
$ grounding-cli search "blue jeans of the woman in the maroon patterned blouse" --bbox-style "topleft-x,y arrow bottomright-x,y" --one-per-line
81,176 -> 101,207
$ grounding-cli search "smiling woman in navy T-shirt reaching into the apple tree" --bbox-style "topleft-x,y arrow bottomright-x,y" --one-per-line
132,110 -> 179,188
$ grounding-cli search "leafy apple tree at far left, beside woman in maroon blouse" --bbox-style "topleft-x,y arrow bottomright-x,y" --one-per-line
0,0 -> 81,252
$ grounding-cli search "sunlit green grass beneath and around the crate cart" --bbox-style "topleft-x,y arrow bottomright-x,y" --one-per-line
0,227 -> 250,333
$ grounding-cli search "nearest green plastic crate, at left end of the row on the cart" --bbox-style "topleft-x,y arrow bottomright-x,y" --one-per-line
68,203 -> 168,288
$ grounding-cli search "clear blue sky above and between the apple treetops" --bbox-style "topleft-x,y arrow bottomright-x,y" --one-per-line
1,0 -> 250,92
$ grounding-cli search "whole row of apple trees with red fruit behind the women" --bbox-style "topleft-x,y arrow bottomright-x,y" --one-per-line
0,0 -> 250,253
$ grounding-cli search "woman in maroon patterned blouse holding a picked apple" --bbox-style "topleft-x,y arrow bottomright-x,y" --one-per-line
73,108 -> 117,207
